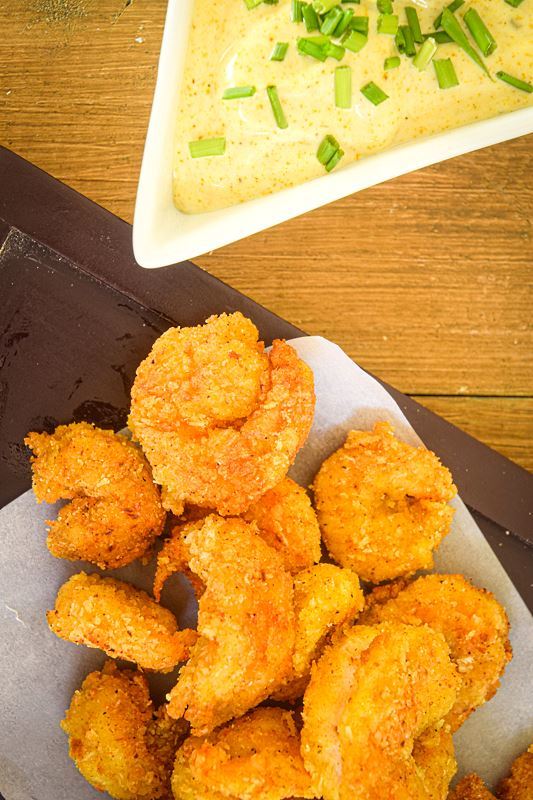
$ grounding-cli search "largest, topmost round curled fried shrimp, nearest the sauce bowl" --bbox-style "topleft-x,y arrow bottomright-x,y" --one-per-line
129,312 -> 315,516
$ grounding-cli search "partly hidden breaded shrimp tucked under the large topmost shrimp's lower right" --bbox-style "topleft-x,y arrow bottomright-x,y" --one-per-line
243,478 -> 321,574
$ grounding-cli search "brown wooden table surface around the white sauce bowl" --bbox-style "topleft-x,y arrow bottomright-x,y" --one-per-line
0,0 -> 533,469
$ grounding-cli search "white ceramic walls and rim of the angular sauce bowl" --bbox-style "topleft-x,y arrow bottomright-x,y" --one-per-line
133,0 -> 533,267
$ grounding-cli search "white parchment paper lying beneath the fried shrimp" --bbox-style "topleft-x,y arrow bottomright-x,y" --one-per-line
0,337 -> 533,800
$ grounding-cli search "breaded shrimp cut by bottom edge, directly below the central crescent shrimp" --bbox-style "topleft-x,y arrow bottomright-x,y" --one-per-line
172,708 -> 315,800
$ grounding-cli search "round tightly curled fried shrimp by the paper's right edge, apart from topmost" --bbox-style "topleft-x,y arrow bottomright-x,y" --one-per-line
313,422 -> 457,583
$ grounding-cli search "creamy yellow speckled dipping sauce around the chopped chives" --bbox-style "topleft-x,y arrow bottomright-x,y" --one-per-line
174,0 -> 533,213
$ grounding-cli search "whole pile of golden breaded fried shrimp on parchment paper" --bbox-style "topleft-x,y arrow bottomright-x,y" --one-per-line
26,312 -> 533,800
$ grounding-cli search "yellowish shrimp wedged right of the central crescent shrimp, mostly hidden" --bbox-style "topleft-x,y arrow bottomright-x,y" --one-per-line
274,564 -> 365,700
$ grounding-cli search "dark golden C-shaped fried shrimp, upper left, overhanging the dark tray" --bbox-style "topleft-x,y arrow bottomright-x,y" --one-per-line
24,422 -> 165,569
